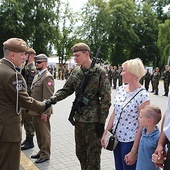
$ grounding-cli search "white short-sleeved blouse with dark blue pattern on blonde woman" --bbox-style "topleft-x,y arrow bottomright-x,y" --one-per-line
113,85 -> 150,142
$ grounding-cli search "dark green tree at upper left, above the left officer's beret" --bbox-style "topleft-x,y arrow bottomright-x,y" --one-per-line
0,0 -> 59,55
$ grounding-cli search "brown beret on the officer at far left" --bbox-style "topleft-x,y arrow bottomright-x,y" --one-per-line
3,38 -> 29,53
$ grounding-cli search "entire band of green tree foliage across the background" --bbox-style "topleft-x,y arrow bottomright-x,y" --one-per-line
0,0 -> 170,67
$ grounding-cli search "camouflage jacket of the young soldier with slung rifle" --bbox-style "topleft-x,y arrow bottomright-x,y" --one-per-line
55,64 -> 111,123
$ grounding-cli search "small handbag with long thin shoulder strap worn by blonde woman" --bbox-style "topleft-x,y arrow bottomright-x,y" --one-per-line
104,89 -> 144,151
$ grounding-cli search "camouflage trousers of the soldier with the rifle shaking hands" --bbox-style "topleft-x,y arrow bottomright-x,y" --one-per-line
75,121 -> 102,170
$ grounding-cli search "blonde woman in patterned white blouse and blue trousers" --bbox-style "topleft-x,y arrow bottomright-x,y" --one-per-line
101,58 -> 150,170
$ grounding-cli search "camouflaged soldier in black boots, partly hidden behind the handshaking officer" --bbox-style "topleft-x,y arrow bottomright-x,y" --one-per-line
21,48 -> 37,150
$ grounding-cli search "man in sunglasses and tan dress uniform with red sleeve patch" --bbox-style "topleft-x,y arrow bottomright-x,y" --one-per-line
29,54 -> 54,163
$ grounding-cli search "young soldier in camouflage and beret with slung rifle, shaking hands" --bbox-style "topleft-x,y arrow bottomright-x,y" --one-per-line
51,43 -> 111,170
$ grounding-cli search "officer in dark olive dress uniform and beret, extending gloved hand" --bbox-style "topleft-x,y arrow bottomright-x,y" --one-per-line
0,38 -> 50,170
